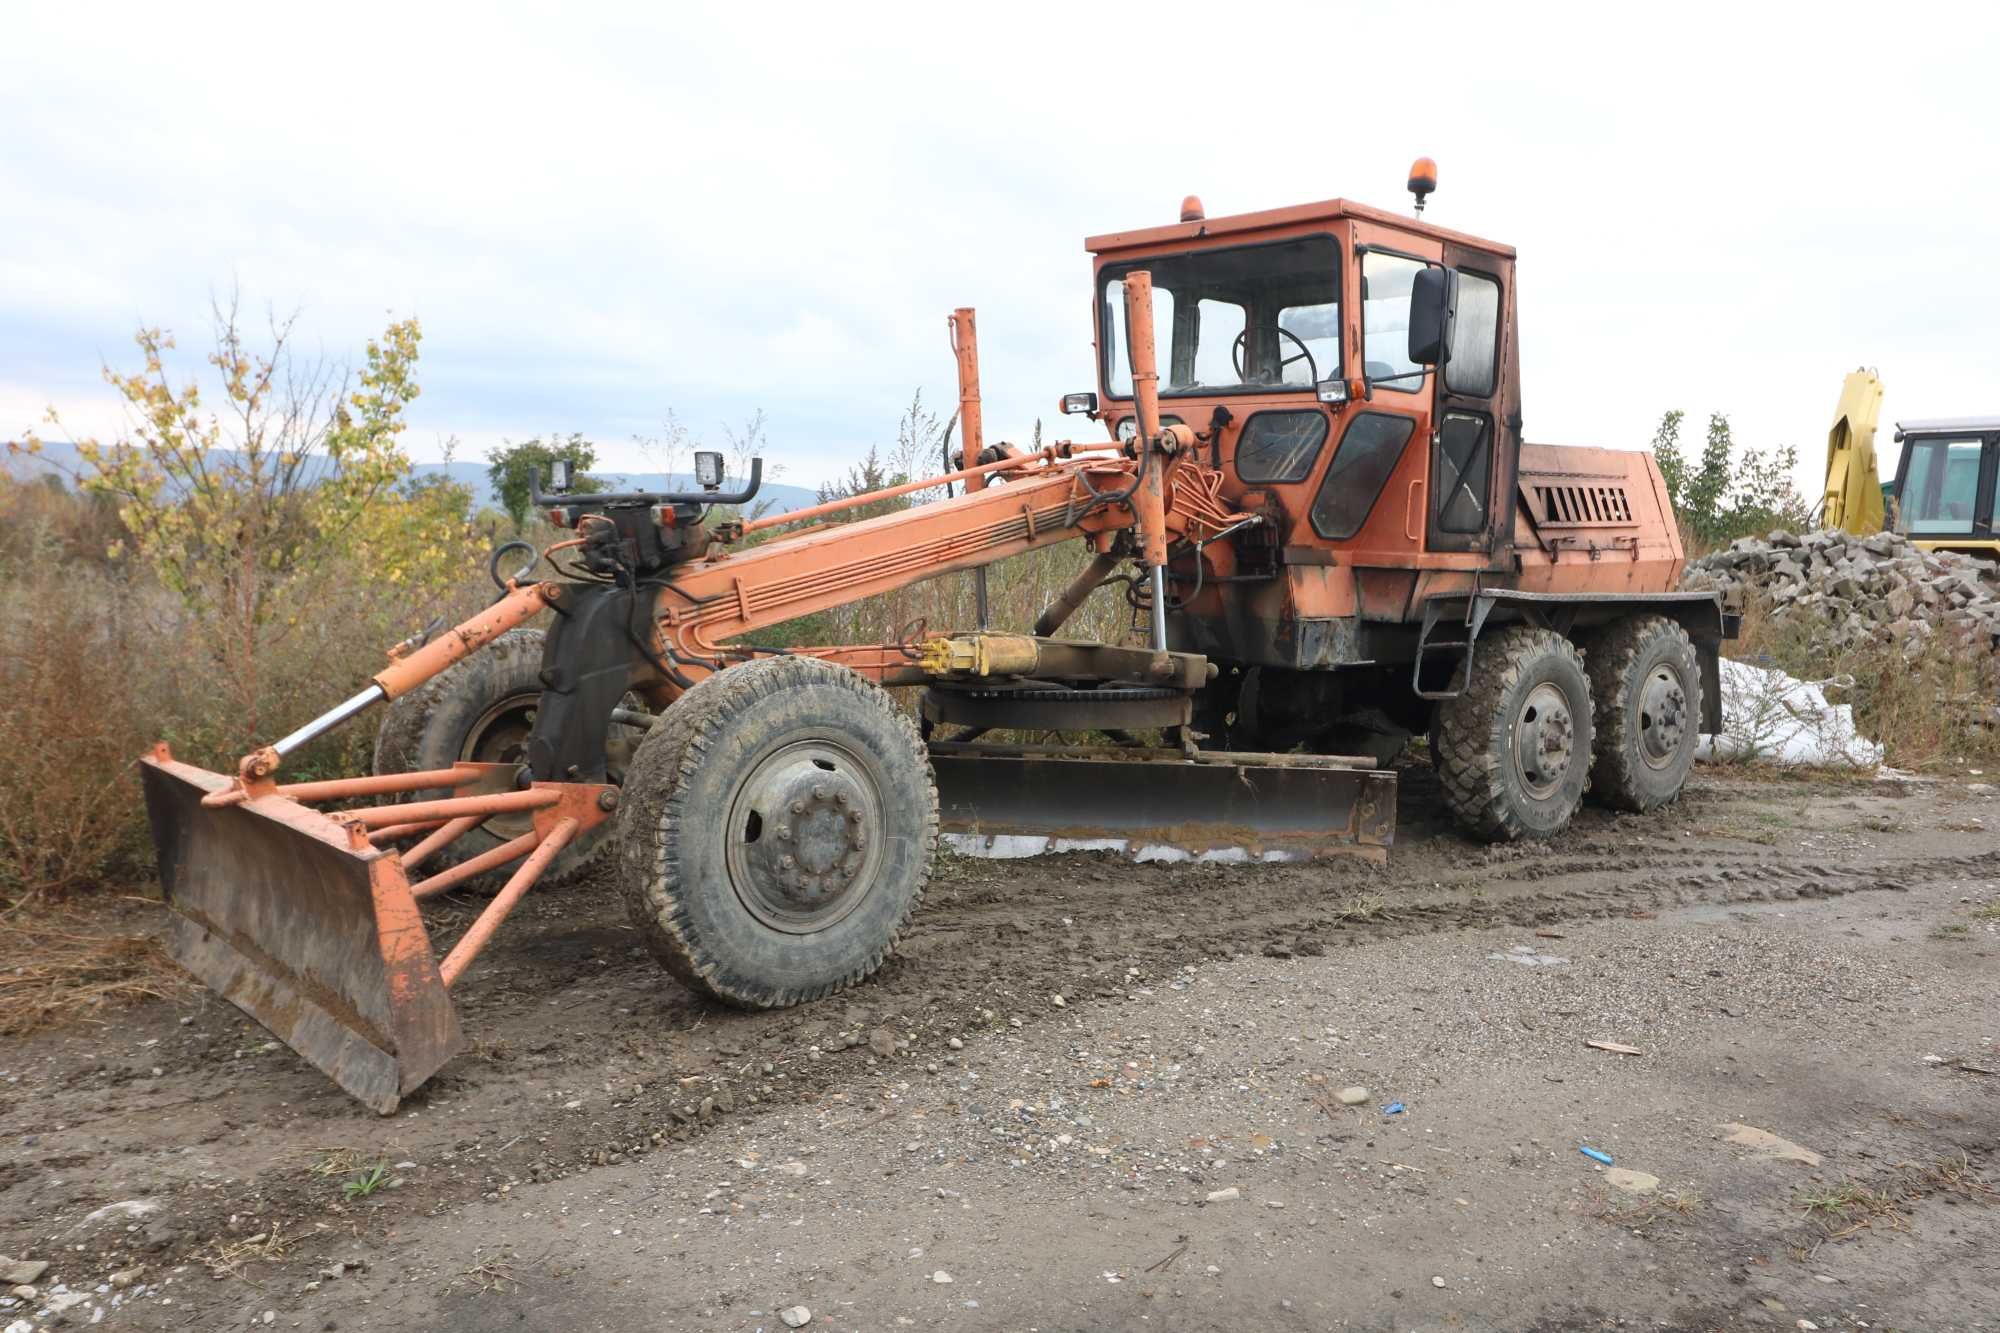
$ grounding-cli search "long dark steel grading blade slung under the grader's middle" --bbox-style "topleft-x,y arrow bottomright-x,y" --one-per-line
930,745 -> 1396,861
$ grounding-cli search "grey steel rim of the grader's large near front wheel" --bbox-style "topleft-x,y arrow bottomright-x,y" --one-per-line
722,741 -> 884,935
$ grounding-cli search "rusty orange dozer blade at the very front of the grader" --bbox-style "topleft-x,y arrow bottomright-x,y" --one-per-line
140,753 -> 464,1115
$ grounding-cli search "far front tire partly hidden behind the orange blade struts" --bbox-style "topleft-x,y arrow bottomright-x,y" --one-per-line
374,628 -> 618,885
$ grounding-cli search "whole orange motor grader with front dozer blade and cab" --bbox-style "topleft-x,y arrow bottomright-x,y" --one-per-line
142,164 -> 1732,1111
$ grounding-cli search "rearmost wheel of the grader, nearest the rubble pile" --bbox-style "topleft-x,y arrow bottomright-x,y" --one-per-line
1584,616 -> 1702,811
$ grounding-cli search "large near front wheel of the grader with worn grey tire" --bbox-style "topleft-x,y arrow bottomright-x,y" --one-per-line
618,656 -> 938,1009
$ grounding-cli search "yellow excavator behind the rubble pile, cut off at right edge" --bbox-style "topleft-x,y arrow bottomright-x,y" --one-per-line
1820,368 -> 2000,560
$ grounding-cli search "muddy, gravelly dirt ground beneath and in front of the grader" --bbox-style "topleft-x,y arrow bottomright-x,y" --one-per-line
0,756 -> 2000,1333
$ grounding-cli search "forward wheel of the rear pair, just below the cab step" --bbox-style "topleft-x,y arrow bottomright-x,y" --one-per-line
1436,624 -> 1590,843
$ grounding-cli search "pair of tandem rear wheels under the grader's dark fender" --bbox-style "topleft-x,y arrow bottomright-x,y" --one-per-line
1434,616 -> 1702,843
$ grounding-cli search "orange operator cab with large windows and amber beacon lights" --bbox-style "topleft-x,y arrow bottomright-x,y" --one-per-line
1064,162 -> 1520,570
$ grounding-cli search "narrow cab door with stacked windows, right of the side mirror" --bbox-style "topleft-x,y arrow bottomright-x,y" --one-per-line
1424,244 -> 1520,554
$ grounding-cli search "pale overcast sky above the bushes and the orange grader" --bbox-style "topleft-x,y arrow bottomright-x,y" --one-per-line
0,0 -> 2000,490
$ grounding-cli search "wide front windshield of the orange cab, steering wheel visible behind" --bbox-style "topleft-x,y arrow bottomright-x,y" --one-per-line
1098,236 -> 1340,398
